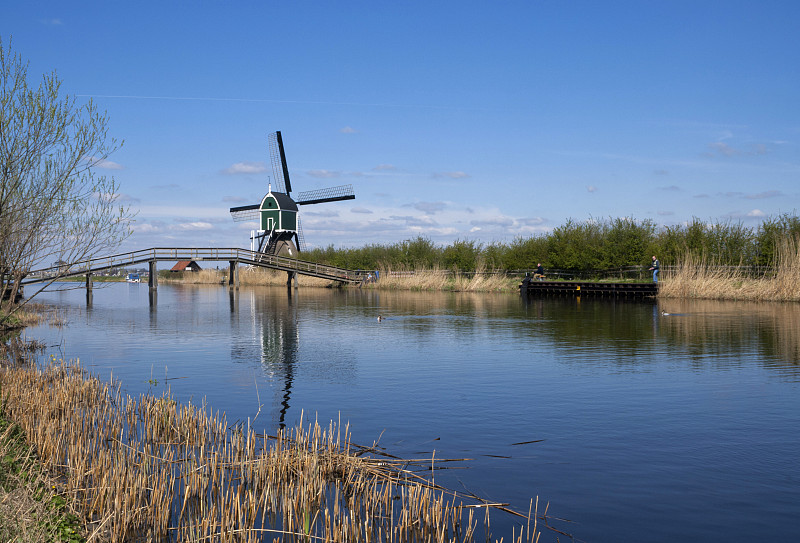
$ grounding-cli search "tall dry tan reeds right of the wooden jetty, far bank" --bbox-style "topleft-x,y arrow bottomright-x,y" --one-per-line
659,237 -> 800,302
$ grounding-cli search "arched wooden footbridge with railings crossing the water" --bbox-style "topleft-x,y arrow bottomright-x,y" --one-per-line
20,247 -> 369,289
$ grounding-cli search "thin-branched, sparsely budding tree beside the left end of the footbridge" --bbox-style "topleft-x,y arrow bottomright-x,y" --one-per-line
0,38 -> 132,328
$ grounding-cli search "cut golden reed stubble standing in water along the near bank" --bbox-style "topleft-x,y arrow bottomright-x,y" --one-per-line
0,357 -> 546,543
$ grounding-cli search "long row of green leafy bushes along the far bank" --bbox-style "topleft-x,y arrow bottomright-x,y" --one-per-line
303,215 -> 800,272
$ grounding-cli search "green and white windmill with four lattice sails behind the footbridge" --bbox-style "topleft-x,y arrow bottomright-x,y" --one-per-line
230,131 -> 356,257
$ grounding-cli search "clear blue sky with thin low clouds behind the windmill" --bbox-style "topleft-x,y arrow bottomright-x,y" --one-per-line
6,0 -> 800,250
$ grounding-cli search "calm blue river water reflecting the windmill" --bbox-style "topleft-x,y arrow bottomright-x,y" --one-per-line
26,284 -> 800,542
